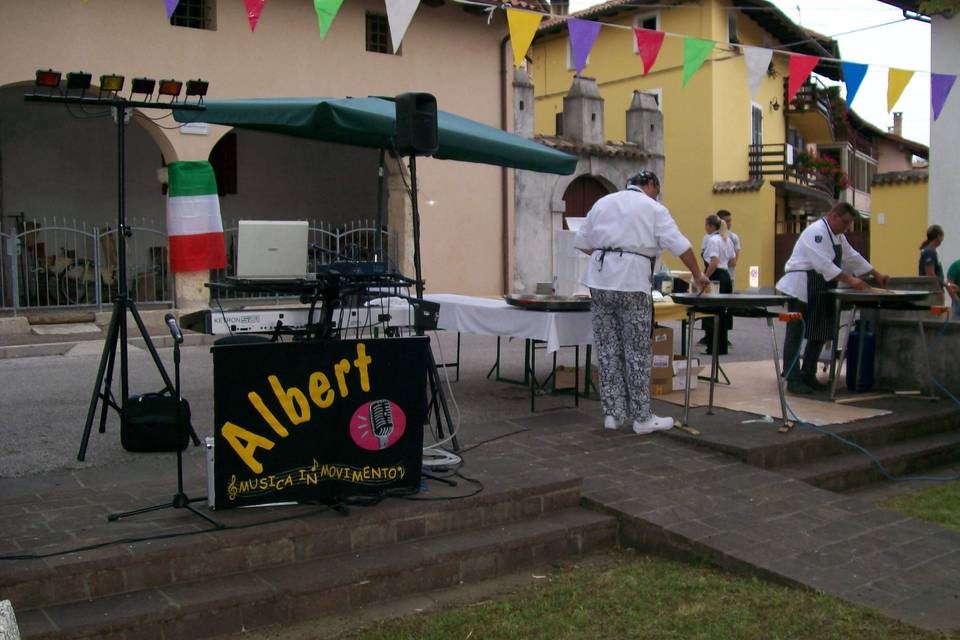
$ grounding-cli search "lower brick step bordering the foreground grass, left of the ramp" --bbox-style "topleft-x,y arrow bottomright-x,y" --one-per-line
17,507 -> 617,640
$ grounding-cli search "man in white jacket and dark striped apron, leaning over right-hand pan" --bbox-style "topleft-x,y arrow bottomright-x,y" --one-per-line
777,202 -> 889,394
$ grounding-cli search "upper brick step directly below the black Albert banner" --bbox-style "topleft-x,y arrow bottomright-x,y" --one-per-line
0,478 -> 580,610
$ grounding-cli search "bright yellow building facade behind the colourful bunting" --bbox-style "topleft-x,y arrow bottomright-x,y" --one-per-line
530,0 -> 836,289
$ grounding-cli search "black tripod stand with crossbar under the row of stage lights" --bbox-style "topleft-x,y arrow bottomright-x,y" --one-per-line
24,94 -> 206,461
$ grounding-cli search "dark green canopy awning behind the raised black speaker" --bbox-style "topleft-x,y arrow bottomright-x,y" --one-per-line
173,98 -> 577,175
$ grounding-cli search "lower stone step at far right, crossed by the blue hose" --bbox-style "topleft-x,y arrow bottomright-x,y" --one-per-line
777,430 -> 960,491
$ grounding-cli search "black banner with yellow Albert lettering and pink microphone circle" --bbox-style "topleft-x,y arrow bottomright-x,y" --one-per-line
211,337 -> 430,509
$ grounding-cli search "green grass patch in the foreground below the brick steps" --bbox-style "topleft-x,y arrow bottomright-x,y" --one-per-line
342,552 -> 944,640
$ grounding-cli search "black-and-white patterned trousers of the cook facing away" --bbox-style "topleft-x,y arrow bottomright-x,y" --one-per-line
590,289 -> 653,421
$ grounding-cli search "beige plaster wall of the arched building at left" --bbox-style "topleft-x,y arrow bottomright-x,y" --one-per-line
0,0 -> 506,294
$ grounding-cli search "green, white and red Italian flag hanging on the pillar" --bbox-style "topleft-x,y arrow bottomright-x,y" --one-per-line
167,160 -> 227,272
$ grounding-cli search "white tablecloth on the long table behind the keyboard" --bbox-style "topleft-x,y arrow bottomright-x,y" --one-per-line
424,293 -> 593,352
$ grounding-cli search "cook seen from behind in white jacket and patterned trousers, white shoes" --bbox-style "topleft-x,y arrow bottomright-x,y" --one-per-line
574,171 -> 710,434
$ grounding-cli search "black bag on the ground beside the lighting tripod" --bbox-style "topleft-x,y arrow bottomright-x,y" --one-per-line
120,393 -> 191,452
